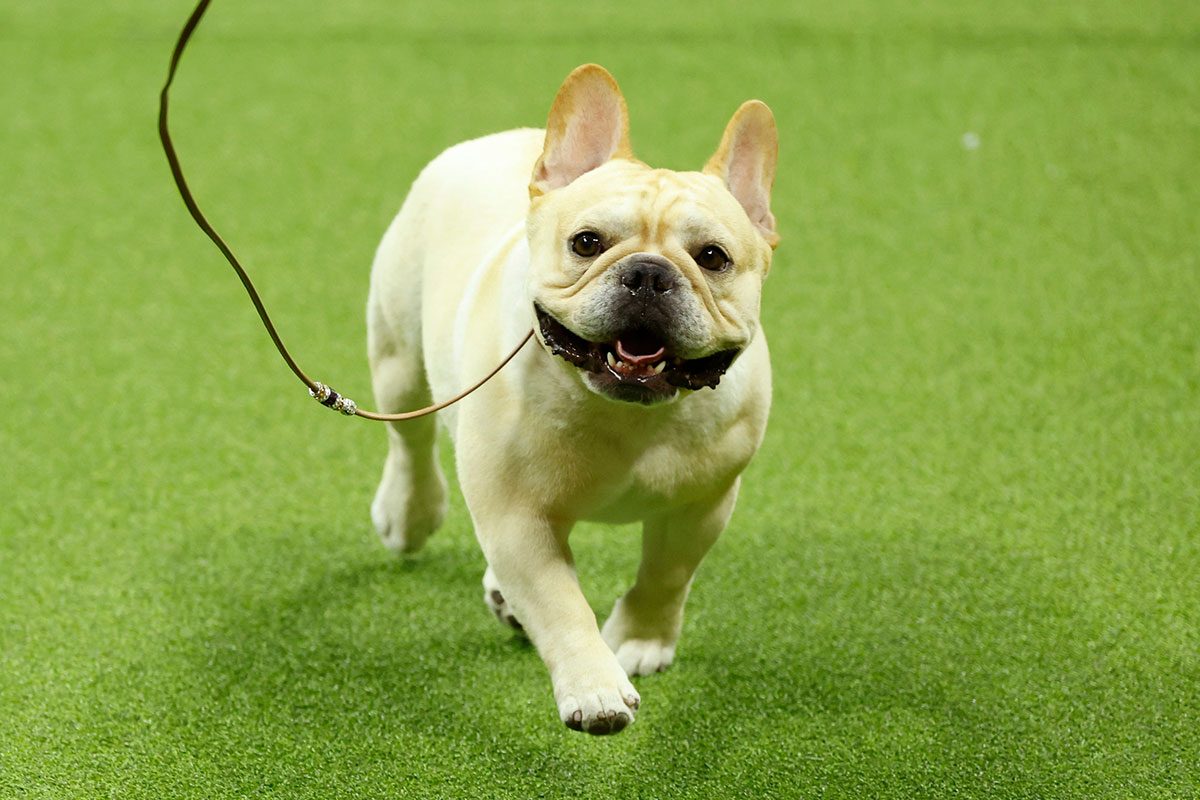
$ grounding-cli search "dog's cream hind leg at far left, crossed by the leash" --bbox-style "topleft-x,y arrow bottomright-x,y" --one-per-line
367,264 -> 446,553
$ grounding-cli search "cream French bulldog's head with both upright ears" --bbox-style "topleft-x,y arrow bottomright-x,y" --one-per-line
527,65 -> 778,404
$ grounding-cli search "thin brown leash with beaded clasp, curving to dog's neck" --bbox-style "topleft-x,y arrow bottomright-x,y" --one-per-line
158,0 -> 533,422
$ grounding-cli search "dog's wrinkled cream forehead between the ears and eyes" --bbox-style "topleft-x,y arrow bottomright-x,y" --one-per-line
549,162 -> 749,247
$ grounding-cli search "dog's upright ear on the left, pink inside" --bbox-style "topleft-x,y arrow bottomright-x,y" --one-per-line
529,64 -> 634,197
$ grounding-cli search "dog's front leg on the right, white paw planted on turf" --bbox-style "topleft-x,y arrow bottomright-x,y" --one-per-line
604,480 -> 739,675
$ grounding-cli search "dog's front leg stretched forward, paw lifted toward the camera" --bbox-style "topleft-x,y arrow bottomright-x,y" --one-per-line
475,513 -> 641,734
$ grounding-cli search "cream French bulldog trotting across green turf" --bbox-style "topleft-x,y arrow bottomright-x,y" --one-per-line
367,65 -> 778,734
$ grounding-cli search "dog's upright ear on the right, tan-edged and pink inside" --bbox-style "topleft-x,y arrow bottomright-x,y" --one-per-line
704,100 -> 779,247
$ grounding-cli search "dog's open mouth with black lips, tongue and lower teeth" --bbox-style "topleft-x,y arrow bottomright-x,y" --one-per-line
534,303 -> 739,403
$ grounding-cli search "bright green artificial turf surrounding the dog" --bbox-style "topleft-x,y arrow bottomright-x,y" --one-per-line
0,0 -> 1200,800
